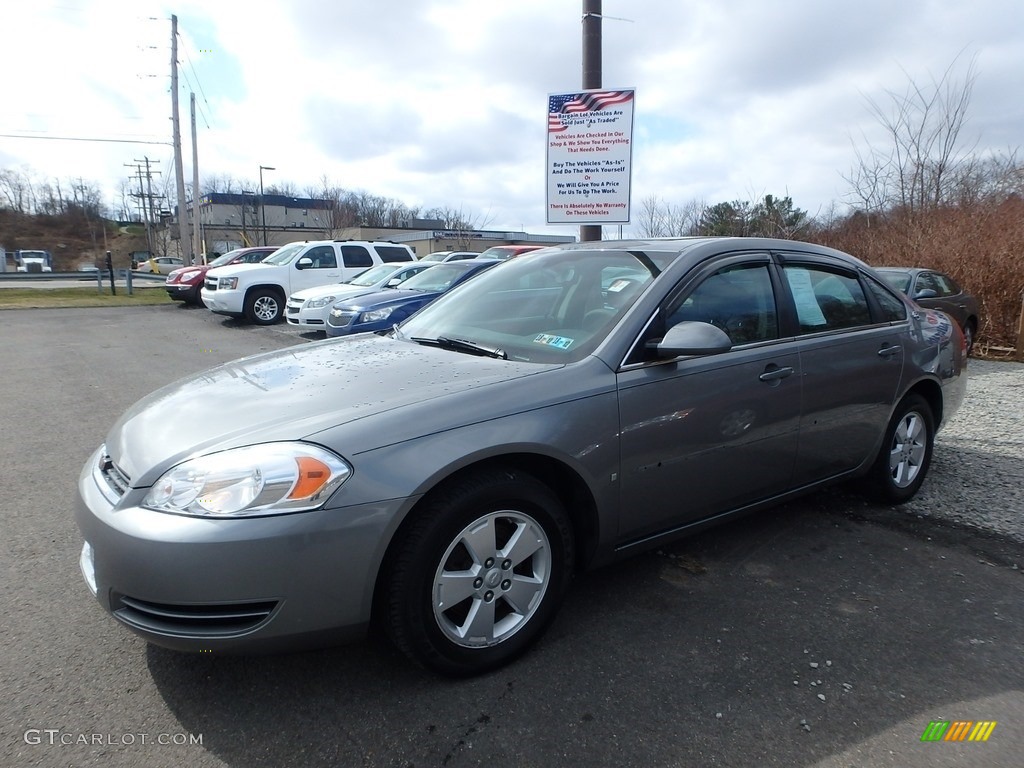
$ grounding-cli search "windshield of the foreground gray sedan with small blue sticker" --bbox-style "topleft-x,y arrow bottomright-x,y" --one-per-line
396,250 -> 676,362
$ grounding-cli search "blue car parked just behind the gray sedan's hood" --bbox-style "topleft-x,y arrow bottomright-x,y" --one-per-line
327,259 -> 502,336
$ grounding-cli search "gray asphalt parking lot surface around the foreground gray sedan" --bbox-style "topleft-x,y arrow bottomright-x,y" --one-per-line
0,305 -> 1024,768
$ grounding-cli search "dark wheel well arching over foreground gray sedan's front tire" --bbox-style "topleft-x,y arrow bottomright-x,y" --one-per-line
373,454 -> 598,626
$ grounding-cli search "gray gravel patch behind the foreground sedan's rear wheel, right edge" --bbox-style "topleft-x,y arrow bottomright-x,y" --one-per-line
900,359 -> 1024,544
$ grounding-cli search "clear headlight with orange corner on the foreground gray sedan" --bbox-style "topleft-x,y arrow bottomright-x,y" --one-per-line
142,442 -> 352,517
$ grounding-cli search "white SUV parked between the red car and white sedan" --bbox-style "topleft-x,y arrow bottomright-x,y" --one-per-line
202,240 -> 415,326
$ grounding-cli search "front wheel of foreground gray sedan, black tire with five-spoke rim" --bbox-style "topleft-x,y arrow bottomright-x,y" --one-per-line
385,469 -> 573,677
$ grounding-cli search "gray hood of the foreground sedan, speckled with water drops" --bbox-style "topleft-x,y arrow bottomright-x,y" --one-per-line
106,334 -> 560,487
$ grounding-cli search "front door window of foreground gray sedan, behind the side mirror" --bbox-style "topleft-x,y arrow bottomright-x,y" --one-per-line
666,264 -> 778,345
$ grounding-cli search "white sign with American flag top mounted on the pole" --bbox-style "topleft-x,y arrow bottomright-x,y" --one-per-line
547,88 -> 636,224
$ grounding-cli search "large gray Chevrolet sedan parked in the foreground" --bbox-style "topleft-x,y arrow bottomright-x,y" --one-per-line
77,239 -> 966,675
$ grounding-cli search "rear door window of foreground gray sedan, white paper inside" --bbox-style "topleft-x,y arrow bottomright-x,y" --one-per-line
783,264 -> 871,334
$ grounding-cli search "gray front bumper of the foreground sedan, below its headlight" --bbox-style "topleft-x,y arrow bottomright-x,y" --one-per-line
76,452 -> 400,652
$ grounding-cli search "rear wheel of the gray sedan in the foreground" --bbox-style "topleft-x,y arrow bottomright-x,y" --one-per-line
870,394 -> 935,504
